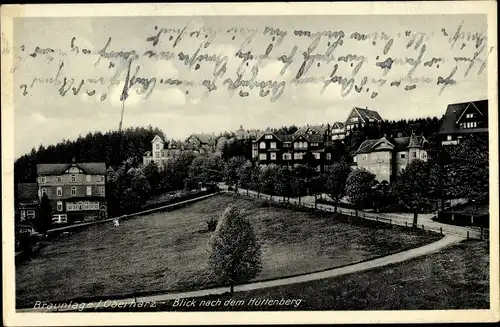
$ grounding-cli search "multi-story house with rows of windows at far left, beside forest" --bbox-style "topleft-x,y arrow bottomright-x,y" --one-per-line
36,160 -> 107,223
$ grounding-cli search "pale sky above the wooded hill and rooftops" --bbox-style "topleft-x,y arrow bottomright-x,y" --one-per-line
13,15 -> 489,158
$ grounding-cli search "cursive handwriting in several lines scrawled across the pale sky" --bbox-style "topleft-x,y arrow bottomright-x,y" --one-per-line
2,20 -> 493,102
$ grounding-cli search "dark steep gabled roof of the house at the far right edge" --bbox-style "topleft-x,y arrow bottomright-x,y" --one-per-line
439,100 -> 488,134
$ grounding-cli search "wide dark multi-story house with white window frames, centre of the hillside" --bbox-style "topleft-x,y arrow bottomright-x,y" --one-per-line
252,131 -> 332,172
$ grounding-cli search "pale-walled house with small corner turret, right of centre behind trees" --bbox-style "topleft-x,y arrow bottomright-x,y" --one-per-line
353,134 -> 429,182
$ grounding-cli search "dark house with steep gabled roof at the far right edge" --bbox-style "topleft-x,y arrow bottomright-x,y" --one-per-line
438,100 -> 488,145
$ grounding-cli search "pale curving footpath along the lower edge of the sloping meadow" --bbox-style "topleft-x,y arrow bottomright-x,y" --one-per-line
16,235 -> 464,312
